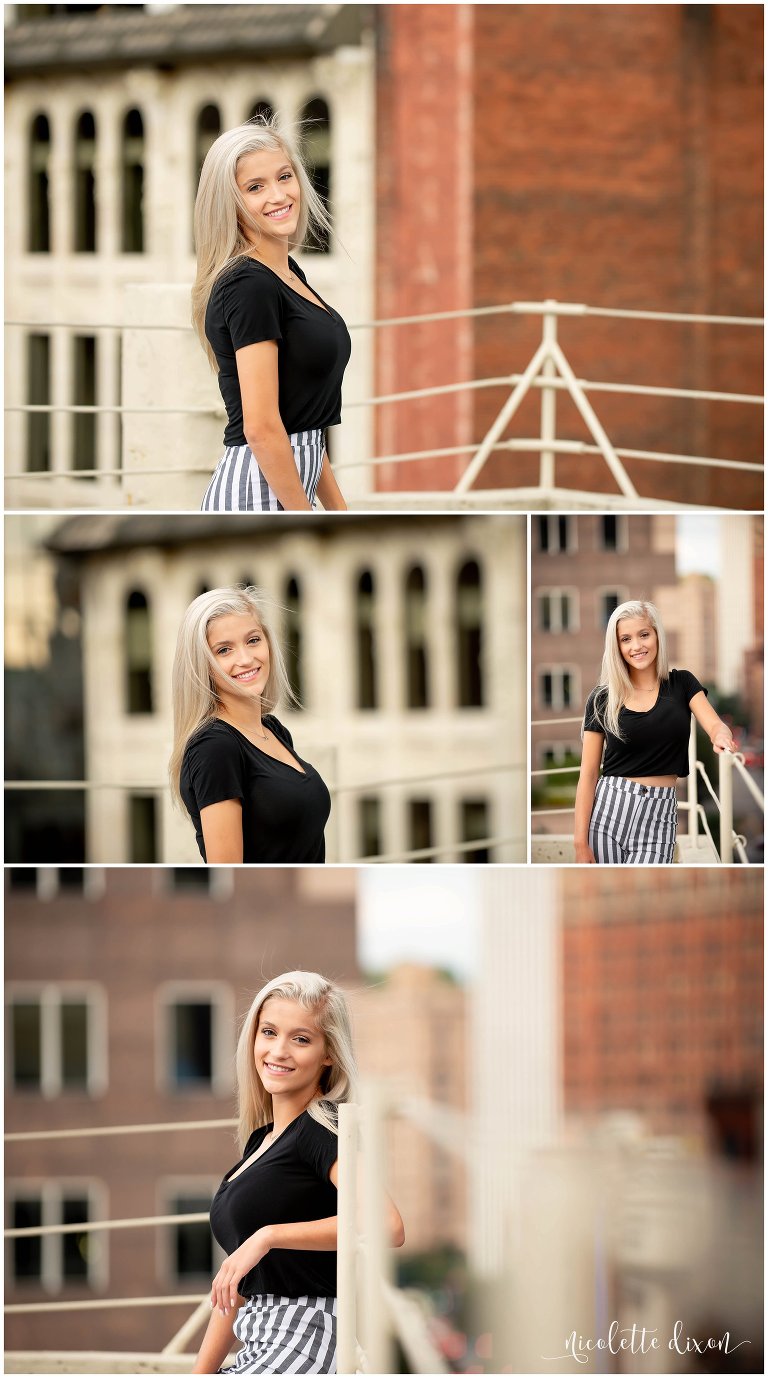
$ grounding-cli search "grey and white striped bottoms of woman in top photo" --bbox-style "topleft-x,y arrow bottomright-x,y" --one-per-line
200,430 -> 325,513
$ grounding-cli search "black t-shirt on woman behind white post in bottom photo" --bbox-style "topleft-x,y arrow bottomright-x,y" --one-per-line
211,1111 -> 339,1297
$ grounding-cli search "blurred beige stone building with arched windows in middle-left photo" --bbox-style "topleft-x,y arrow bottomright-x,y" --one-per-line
51,515 -> 527,864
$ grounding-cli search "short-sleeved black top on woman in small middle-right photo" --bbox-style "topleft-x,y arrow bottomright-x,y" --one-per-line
585,670 -> 707,776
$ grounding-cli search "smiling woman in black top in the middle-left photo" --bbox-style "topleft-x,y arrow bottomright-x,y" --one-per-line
170,587 -> 331,863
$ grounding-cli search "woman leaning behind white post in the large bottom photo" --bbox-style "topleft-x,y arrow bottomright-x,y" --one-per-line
192,971 -> 404,1374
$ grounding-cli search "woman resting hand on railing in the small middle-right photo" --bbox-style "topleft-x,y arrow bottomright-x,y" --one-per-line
574,602 -> 736,865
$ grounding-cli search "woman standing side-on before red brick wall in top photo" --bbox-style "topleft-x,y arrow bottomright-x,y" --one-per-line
192,120 -> 352,511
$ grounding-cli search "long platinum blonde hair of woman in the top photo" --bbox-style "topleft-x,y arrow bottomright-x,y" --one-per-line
192,116 -> 331,372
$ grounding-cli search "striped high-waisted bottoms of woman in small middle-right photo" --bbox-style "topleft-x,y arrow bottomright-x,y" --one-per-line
589,776 -> 677,865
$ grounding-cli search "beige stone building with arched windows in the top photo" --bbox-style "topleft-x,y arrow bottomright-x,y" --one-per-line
4,4 -> 374,510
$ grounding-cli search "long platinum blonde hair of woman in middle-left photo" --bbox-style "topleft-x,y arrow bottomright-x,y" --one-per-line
168,584 -> 298,809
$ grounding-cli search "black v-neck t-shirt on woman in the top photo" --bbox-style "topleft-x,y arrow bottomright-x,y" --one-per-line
205,258 -> 352,446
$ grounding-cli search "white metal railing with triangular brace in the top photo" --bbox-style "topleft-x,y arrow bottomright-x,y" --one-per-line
6,299 -> 764,503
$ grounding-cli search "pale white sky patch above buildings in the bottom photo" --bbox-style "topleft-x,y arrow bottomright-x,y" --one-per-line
357,865 -> 481,980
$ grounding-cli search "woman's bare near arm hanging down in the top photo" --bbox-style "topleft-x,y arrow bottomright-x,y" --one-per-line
234,340 -> 312,511
